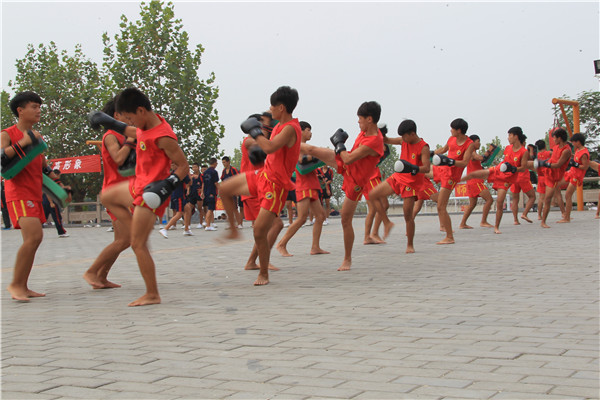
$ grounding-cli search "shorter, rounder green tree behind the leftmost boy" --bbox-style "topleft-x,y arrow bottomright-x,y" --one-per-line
2,42 -> 104,201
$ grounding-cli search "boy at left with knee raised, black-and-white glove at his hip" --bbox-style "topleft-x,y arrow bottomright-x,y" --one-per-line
92,88 -> 190,307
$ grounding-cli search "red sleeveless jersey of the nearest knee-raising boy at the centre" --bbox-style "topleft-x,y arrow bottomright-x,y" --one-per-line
264,118 -> 302,190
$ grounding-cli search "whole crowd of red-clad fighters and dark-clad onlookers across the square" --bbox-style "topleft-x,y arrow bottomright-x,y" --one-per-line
1,86 -> 598,306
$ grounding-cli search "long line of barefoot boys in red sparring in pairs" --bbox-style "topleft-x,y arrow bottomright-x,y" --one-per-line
2,86 -> 597,306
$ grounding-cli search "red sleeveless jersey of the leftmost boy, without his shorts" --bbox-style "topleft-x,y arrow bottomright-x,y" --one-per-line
4,125 -> 44,202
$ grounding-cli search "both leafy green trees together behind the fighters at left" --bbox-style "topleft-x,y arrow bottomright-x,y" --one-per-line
1,1 -> 225,201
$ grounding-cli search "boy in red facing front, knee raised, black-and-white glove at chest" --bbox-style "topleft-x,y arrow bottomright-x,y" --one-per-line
370,119 -> 430,253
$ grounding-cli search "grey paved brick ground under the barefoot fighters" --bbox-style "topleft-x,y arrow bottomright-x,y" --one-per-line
1,211 -> 599,399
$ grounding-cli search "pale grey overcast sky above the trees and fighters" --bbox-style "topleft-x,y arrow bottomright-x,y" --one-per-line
1,0 -> 600,159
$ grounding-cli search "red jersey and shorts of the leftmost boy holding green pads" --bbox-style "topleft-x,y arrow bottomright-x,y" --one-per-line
4,125 -> 46,229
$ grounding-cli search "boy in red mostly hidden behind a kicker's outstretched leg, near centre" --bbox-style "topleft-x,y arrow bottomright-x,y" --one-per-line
277,121 -> 329,257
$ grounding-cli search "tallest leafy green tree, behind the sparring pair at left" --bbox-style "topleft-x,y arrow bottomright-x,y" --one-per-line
103,1 -> 225,160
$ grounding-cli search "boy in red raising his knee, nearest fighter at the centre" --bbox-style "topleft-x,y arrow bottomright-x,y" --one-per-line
221,86 -> 302,286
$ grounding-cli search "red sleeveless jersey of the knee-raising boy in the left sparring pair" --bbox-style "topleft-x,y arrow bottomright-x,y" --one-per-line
133,114 -> 177,195
